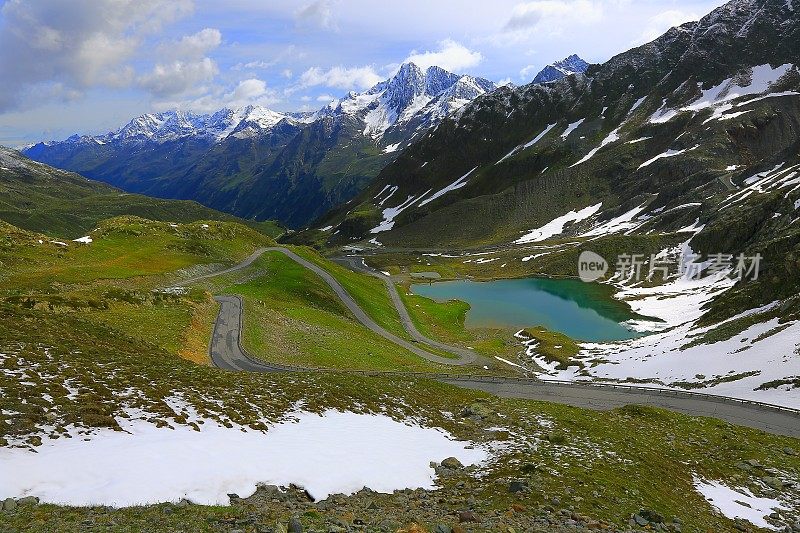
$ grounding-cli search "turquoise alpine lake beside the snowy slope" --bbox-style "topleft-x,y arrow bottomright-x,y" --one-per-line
411,278 -> 643,342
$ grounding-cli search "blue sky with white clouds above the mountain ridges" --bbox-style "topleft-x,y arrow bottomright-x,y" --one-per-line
0,0 -> 724,146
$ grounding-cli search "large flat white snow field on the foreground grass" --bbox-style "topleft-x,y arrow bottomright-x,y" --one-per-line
0,410 -> 488,507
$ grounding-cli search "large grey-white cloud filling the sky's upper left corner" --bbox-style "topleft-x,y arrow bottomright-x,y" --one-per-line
0,0 -> 193,111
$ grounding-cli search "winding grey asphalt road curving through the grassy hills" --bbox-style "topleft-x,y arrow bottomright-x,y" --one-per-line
189,248 -> 800,437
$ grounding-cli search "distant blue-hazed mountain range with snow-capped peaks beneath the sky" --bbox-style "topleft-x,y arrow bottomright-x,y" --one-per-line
24,63 -> 495,226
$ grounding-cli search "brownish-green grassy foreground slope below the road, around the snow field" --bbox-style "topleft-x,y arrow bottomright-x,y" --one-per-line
0,278 -> 800,532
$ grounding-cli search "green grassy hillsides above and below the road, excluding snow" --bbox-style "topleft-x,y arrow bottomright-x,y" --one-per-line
0,217 -> 800,531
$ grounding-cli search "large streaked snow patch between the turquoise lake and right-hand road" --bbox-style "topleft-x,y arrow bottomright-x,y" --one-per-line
528,242 -> 800,407
